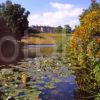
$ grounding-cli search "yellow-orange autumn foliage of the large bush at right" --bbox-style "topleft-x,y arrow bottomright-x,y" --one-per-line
70,10 -> 100,66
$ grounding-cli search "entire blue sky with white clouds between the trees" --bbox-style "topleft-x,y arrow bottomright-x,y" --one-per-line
0,0 -> 100,28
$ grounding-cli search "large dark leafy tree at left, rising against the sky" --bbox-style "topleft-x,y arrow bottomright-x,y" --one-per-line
1,0 -> 30,40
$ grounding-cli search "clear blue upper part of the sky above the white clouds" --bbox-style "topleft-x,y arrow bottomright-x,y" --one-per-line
0,0 -> 91,13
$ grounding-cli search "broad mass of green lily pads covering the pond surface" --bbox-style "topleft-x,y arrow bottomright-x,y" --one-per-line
0,54 -> 71,100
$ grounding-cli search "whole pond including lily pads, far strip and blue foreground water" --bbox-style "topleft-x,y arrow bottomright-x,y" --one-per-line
0,44 -> 76,100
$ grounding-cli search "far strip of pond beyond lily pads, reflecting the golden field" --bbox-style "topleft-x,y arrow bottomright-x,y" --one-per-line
22,44 -> 56,57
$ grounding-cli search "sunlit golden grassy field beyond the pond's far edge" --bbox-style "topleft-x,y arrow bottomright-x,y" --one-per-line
22,33 -> 70,44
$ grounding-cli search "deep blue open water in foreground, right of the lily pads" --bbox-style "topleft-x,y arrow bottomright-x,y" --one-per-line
38,76 -> 76,100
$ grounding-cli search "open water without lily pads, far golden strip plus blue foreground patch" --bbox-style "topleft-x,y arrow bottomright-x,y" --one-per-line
23,44 -> 76,100
